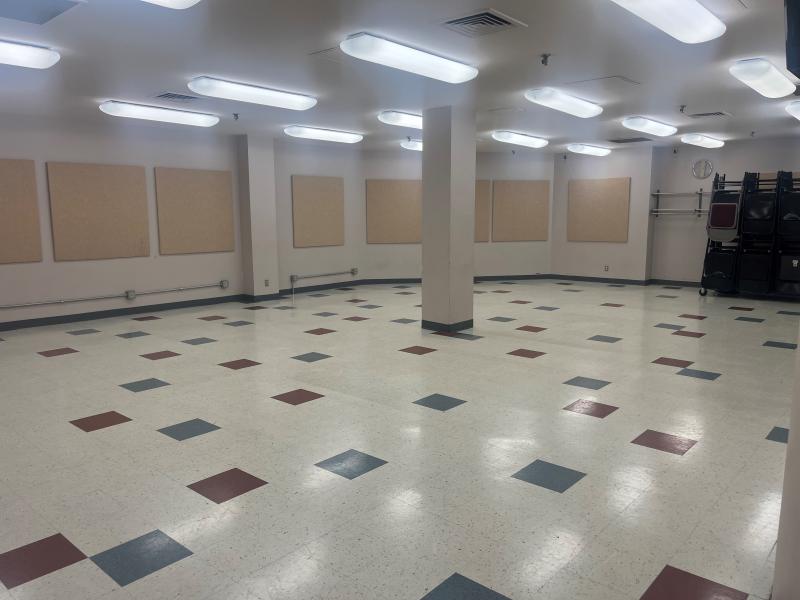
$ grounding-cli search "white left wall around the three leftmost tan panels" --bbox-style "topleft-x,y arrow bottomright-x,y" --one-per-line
0,123 -> 242,321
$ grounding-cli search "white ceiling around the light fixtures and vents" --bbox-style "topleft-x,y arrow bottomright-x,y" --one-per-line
0,0 -> 800,152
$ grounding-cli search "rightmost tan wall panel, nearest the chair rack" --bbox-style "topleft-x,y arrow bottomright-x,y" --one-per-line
567,177 -> 631,243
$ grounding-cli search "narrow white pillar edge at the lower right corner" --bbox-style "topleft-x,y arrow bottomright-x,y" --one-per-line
772,332 -> 800,600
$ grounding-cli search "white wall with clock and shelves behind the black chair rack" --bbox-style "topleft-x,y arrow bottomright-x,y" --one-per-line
651,139 -> 800,281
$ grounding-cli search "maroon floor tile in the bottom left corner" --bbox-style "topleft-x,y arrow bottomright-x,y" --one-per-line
0,533 -> 86,589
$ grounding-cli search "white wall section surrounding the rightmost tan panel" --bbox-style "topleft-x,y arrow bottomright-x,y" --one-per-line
550,147 -> 652,281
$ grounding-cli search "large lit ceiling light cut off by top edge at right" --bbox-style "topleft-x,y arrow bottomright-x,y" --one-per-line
611,0 -> 726,44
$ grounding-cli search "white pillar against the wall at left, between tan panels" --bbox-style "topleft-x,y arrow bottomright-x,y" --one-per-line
237,135 -> 280,300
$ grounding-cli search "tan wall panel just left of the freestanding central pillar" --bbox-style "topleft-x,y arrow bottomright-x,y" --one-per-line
367,179 -> 422,244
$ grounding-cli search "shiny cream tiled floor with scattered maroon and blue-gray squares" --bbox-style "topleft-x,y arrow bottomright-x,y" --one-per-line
0,281 -> 800,600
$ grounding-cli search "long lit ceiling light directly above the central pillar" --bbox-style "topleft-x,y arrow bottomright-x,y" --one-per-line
339,33 -> 478,83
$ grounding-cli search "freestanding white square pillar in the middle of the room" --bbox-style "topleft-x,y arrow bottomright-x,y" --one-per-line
422,106 -> 475,331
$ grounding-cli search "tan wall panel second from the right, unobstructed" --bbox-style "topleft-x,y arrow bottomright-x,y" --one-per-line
492,180 -> 550,242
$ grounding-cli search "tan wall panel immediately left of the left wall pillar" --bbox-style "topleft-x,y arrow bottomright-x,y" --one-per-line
156,167 -> 236,255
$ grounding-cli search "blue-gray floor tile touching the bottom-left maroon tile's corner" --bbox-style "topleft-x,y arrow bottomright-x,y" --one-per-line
91,530 -> 192,586
